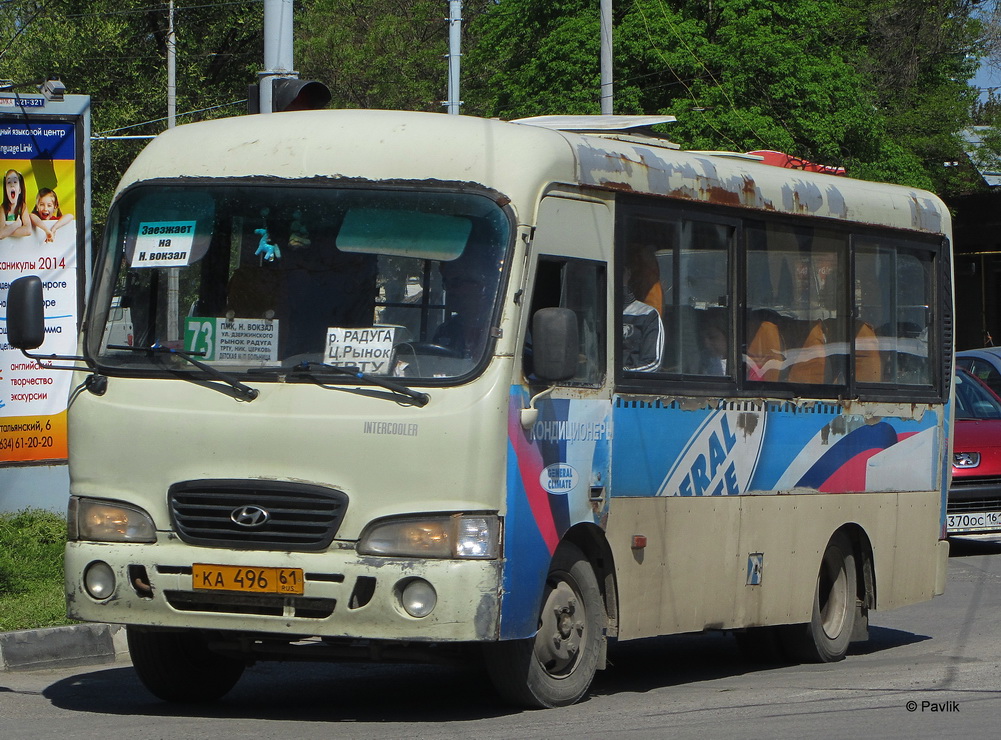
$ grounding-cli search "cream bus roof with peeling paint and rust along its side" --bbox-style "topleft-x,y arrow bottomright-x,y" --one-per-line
121,110 -> 950,233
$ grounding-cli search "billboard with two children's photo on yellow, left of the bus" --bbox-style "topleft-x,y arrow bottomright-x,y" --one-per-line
0,105 -> 84,466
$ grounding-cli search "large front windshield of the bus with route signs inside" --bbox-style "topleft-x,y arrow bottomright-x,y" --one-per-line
87,182 -> 512,381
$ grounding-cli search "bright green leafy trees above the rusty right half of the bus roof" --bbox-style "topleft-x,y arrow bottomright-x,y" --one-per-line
466,0 -> 982,191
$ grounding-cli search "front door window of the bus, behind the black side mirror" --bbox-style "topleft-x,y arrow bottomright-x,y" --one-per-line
523,256 -> 607,386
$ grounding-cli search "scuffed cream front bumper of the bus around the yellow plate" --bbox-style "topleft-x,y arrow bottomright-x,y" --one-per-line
65,534 -> 501,642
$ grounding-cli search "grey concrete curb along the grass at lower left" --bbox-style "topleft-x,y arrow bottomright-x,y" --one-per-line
0,624 -> 128,671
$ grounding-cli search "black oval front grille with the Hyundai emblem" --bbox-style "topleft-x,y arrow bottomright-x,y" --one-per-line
167,481 -> 347,552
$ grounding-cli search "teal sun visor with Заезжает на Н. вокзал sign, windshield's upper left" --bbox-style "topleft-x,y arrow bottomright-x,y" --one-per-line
125,190 -> 215,268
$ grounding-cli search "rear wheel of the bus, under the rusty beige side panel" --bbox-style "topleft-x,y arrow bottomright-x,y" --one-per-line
783,533 -> 858,663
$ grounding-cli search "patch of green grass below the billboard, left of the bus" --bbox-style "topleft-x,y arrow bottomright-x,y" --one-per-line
0,509 -> 68,632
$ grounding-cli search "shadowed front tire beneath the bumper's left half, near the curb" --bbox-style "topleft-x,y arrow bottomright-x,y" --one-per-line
125,627 -> 244,704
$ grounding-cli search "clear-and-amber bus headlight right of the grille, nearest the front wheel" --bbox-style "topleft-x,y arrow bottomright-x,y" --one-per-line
357,514 -> 501,560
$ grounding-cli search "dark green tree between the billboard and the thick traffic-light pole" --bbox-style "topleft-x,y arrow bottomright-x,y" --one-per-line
0,0 -> 263,233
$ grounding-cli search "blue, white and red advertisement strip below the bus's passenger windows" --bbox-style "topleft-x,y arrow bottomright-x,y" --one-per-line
612,399 -> 940,497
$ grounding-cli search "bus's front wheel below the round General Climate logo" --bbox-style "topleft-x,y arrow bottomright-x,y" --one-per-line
484,544 -> 606,709
